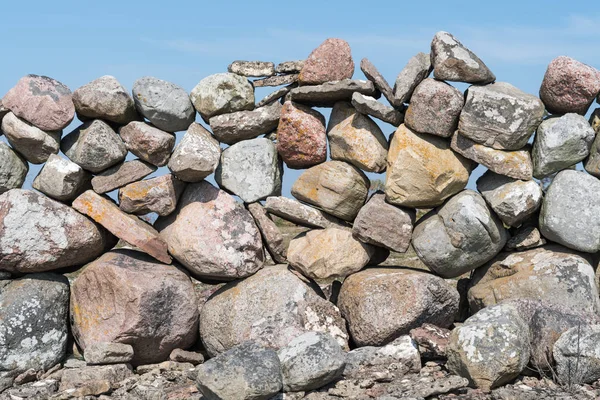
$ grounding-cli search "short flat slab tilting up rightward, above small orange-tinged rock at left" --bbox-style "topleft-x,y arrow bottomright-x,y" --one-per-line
92,159 -> 156,194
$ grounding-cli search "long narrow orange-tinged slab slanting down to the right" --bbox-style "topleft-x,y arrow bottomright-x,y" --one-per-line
72,190 -> 171,264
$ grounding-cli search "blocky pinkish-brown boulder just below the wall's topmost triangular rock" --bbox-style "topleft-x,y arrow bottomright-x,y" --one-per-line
404,78 -> 465,137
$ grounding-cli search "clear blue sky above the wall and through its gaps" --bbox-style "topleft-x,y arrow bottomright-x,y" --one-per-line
0,0 -> 600,196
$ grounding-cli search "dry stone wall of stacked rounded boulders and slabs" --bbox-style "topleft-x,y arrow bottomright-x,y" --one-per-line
0,32 -> 600,399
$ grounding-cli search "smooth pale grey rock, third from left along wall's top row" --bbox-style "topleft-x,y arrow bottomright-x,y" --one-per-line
132,76 -> 196,132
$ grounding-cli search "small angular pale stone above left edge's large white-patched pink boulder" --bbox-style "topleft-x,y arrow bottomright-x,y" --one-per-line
31,154 -> 92,201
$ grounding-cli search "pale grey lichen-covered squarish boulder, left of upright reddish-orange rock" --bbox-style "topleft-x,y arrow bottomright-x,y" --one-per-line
215,138 -> 283,203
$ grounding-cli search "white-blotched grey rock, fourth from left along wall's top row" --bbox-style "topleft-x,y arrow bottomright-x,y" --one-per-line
190,73 -> 254,120
